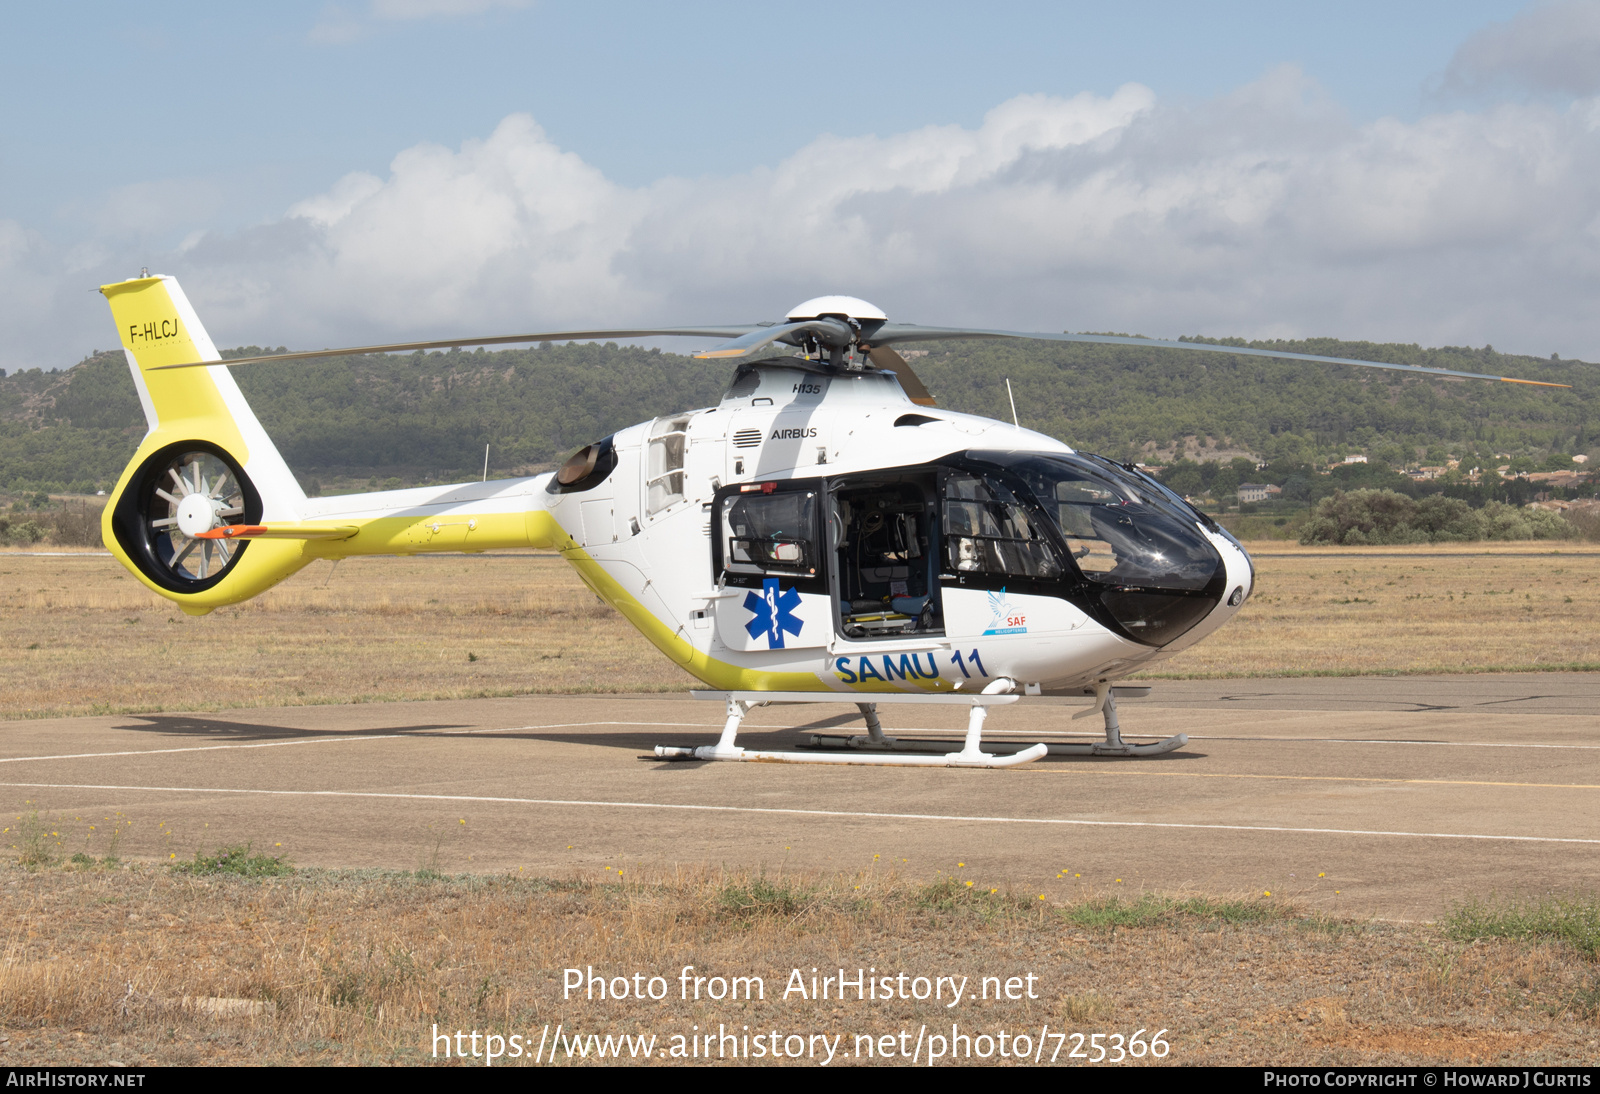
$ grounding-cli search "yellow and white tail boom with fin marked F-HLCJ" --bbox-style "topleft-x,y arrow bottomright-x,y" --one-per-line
101,277 -> 576,614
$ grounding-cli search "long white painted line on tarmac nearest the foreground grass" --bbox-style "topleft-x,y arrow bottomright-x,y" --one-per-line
0,782 -> 1600,846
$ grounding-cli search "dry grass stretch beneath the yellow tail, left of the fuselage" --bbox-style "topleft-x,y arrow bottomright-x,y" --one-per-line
0,552 -> 691,718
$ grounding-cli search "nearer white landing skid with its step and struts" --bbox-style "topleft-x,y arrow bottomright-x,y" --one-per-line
656,680 -> 1048,768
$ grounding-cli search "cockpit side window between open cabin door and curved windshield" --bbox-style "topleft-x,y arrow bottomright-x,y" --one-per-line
944,470 -> 1064,577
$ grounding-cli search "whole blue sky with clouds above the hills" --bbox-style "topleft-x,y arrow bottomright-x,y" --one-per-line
0,0 -> 1600,369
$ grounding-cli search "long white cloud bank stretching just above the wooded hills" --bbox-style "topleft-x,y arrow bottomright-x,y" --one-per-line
15,69 -> 1600,371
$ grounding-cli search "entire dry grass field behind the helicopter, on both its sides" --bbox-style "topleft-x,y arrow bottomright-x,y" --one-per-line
0,544 -> 1600,718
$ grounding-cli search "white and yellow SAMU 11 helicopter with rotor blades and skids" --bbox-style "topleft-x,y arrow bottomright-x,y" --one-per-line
90,272 -> 1562,768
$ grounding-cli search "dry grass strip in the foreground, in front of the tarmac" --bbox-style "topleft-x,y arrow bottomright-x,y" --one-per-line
0,864 -> 1600,1067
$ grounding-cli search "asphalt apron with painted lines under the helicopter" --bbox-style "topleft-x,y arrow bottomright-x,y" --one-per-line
0,673 -> 1600,918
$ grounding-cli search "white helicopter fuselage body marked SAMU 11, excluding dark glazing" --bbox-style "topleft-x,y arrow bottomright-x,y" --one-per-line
299,363 -> 1253,693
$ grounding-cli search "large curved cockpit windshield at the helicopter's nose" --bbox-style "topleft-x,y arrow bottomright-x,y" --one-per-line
973,453 -> 1222,590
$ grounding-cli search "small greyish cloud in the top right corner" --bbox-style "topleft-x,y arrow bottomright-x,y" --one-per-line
1445,0 -> 1600,94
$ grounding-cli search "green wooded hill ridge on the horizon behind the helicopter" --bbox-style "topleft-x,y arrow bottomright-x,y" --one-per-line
0,339 -> 1600,494
